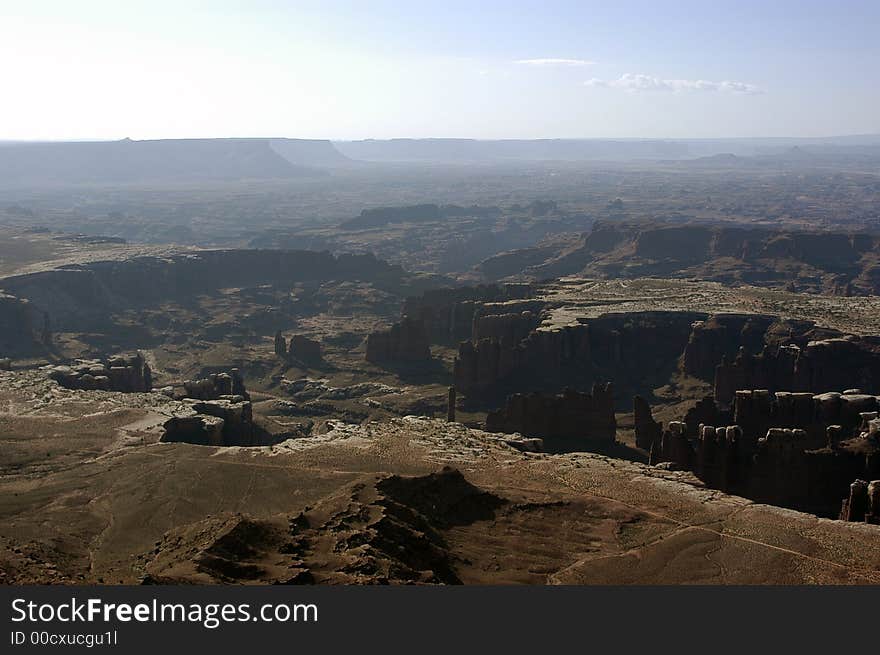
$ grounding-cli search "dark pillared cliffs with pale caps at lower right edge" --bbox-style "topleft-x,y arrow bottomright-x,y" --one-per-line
651,389 -> 880,517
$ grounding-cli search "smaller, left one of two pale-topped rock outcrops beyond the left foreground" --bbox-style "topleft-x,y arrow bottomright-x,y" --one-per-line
48,352 -> 153,393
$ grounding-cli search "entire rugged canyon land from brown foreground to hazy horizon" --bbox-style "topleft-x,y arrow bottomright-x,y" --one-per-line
0,151 -> 880,584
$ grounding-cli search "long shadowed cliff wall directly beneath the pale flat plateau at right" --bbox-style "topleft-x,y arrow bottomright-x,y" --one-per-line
454,301 -> 880,406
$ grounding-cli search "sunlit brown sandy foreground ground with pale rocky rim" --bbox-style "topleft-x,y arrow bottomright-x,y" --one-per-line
0,373 -> 880,584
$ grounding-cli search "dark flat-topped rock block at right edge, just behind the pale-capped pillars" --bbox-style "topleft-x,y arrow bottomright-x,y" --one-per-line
715,335 -> 880,404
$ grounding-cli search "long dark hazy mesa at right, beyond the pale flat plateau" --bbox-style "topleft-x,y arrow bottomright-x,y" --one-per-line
488,221 -> 880,295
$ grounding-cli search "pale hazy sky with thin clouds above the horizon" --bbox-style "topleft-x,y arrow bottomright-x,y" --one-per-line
0,0 -> 880,139
